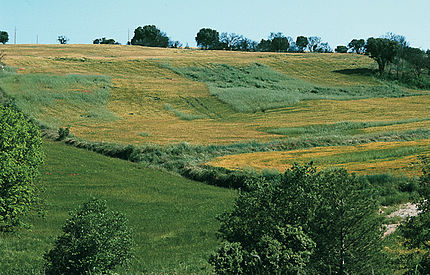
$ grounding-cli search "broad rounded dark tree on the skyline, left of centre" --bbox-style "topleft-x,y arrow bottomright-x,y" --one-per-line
131,25 -> 169,48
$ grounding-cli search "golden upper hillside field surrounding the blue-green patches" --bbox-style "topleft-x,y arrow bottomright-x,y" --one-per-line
1,45 -> 430,144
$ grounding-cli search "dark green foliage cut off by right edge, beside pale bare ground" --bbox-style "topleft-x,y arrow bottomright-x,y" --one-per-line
400,157 -> 430,274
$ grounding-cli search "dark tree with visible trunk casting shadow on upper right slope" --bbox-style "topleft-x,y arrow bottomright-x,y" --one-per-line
366,37 -> 399,75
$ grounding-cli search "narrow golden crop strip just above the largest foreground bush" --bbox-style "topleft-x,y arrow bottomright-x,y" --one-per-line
206,139 -> 430,176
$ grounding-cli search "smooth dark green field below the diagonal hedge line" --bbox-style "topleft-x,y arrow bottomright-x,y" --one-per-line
0,142 -> 235,274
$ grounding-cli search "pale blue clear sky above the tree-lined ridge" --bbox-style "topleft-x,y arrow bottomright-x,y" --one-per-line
0,0 -> 430,50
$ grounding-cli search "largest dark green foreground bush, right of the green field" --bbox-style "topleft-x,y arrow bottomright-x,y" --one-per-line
211,164 -> 385,274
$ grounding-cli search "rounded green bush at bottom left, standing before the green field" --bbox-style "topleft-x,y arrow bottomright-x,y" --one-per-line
44,199 -> 133,274
